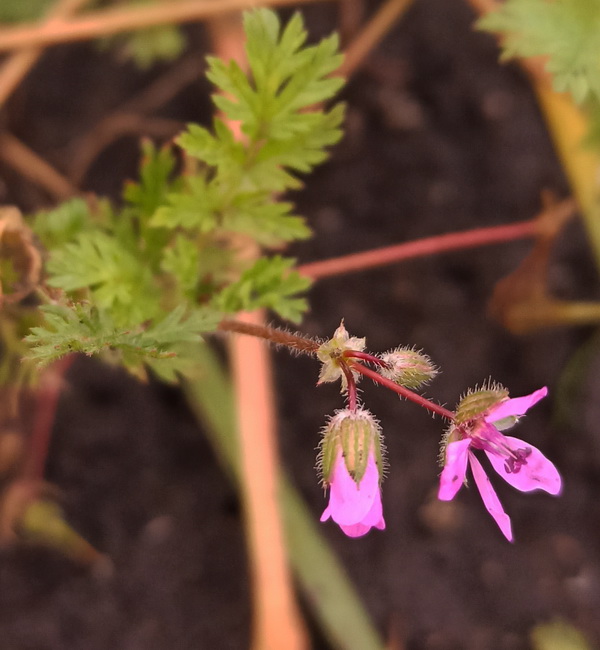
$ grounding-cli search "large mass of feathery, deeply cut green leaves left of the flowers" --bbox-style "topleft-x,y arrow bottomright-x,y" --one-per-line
27,9 -> 343,379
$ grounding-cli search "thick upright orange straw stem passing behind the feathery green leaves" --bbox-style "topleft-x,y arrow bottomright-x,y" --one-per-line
209,15 -> 309,650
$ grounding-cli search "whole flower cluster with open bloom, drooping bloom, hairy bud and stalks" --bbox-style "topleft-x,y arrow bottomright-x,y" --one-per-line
317,322 -> 562,541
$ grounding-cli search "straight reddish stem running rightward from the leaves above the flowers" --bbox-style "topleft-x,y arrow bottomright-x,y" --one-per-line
297,219 -> 538,280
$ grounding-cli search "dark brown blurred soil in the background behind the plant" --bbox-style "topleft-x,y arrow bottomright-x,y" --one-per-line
0,0 -> 600,650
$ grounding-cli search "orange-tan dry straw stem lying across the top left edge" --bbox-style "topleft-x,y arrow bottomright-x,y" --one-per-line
0,0 -> 328,51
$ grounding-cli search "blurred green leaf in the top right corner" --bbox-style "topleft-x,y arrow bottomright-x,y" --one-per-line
478,0 -> 600,102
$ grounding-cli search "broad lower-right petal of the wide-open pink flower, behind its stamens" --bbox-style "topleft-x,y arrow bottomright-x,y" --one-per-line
485,436 -> 562,495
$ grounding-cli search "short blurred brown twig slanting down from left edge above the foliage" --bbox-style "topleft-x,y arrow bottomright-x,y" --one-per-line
0,132 -> 78,195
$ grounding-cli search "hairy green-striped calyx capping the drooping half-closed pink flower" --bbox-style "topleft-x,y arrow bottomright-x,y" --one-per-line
318,408 -> 384,484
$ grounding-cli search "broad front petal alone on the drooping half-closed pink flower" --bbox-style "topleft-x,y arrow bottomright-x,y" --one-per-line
323,454 -> 381,526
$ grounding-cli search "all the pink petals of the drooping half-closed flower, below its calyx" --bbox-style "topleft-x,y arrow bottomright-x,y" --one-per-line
321,449 -> 385,537
